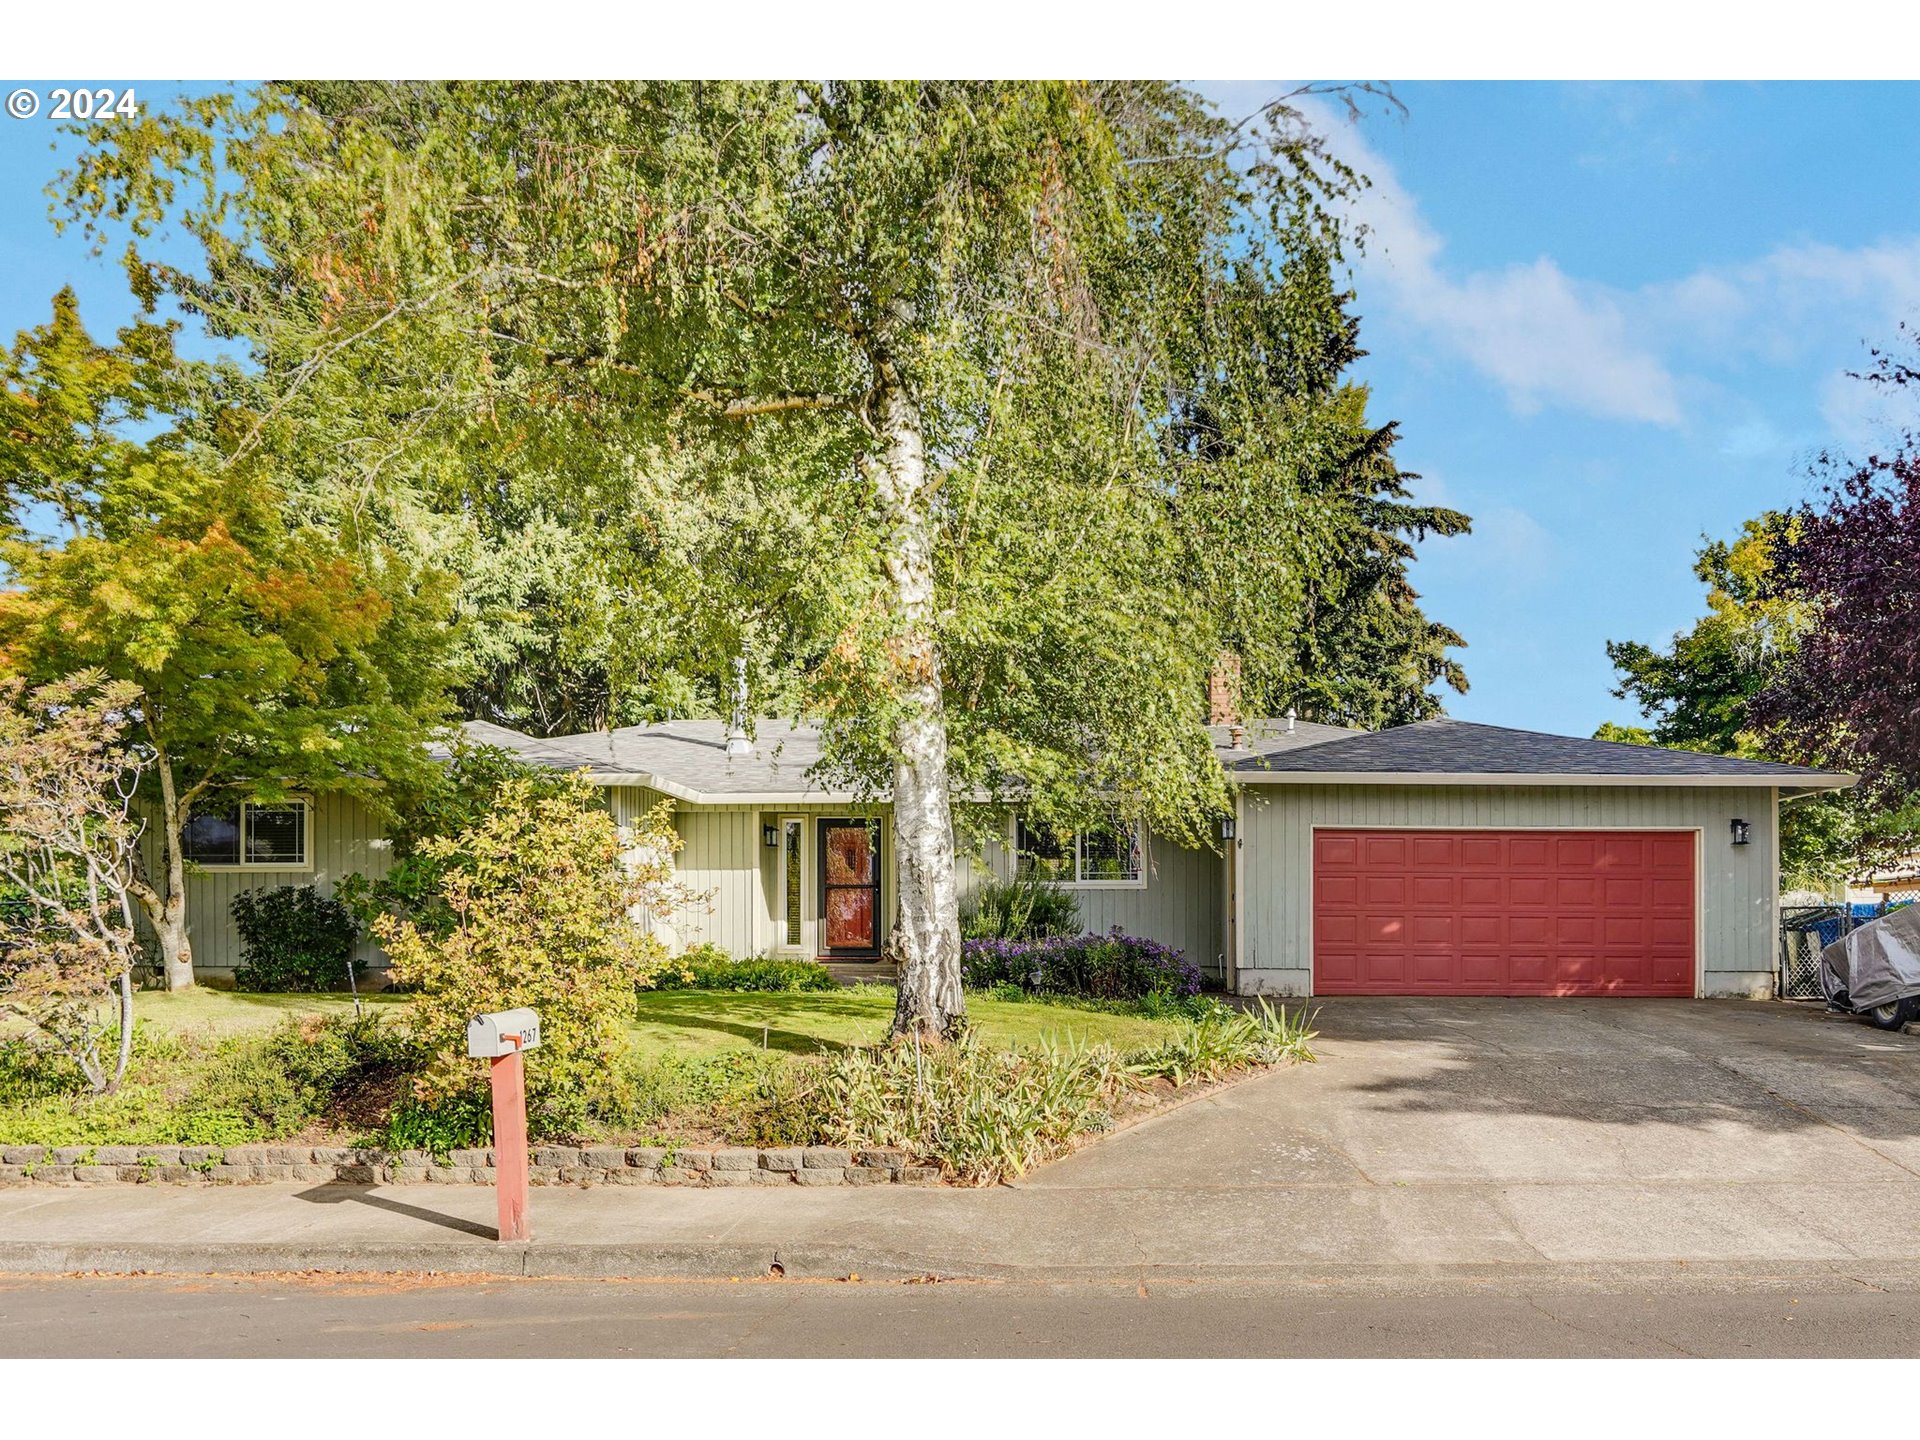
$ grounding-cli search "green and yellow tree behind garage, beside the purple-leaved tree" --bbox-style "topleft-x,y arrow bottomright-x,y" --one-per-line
1596,511 -> 1920,887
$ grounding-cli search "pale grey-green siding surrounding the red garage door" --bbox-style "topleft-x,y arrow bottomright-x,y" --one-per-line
1238,783 -> 1778,996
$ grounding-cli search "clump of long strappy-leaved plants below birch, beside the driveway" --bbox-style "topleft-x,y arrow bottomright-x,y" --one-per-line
801,1035 -> 1139,1185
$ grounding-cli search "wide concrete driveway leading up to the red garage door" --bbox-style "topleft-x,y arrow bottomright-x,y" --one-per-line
1025,998 -> 1920,1273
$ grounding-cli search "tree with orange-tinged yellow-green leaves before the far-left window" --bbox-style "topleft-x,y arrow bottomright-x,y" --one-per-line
0,296 -> 447,989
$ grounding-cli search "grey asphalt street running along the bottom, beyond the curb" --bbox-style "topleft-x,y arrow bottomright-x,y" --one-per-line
0,1275 -> 1920,1357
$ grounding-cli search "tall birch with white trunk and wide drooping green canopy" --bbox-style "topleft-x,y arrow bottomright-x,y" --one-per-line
67,81 -> 1446,1033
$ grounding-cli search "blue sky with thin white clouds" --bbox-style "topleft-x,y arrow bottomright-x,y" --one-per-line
11,81 -> 1920,733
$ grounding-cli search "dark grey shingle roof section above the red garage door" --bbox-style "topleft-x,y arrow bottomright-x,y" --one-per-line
1229,720 -> 1851,787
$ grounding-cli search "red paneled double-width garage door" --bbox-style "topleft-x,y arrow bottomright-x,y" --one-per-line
1313,829 -> 1693,995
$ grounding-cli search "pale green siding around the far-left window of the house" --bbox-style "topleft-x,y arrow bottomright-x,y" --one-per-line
156,795 -> 394,975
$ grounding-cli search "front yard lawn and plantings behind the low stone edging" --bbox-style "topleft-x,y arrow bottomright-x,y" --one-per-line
0,987 -> 1309,1185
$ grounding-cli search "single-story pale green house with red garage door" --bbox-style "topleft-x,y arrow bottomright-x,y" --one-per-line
172,720 -> 1855,996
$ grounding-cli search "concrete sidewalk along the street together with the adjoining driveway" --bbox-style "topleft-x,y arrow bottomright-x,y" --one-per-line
0,1000 -> 1920,1292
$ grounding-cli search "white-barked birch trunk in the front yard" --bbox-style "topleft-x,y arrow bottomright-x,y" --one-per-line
876,363 -> 966,1039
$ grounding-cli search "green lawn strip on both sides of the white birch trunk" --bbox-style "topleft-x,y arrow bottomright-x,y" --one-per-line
632,985 -> 1169,1054
